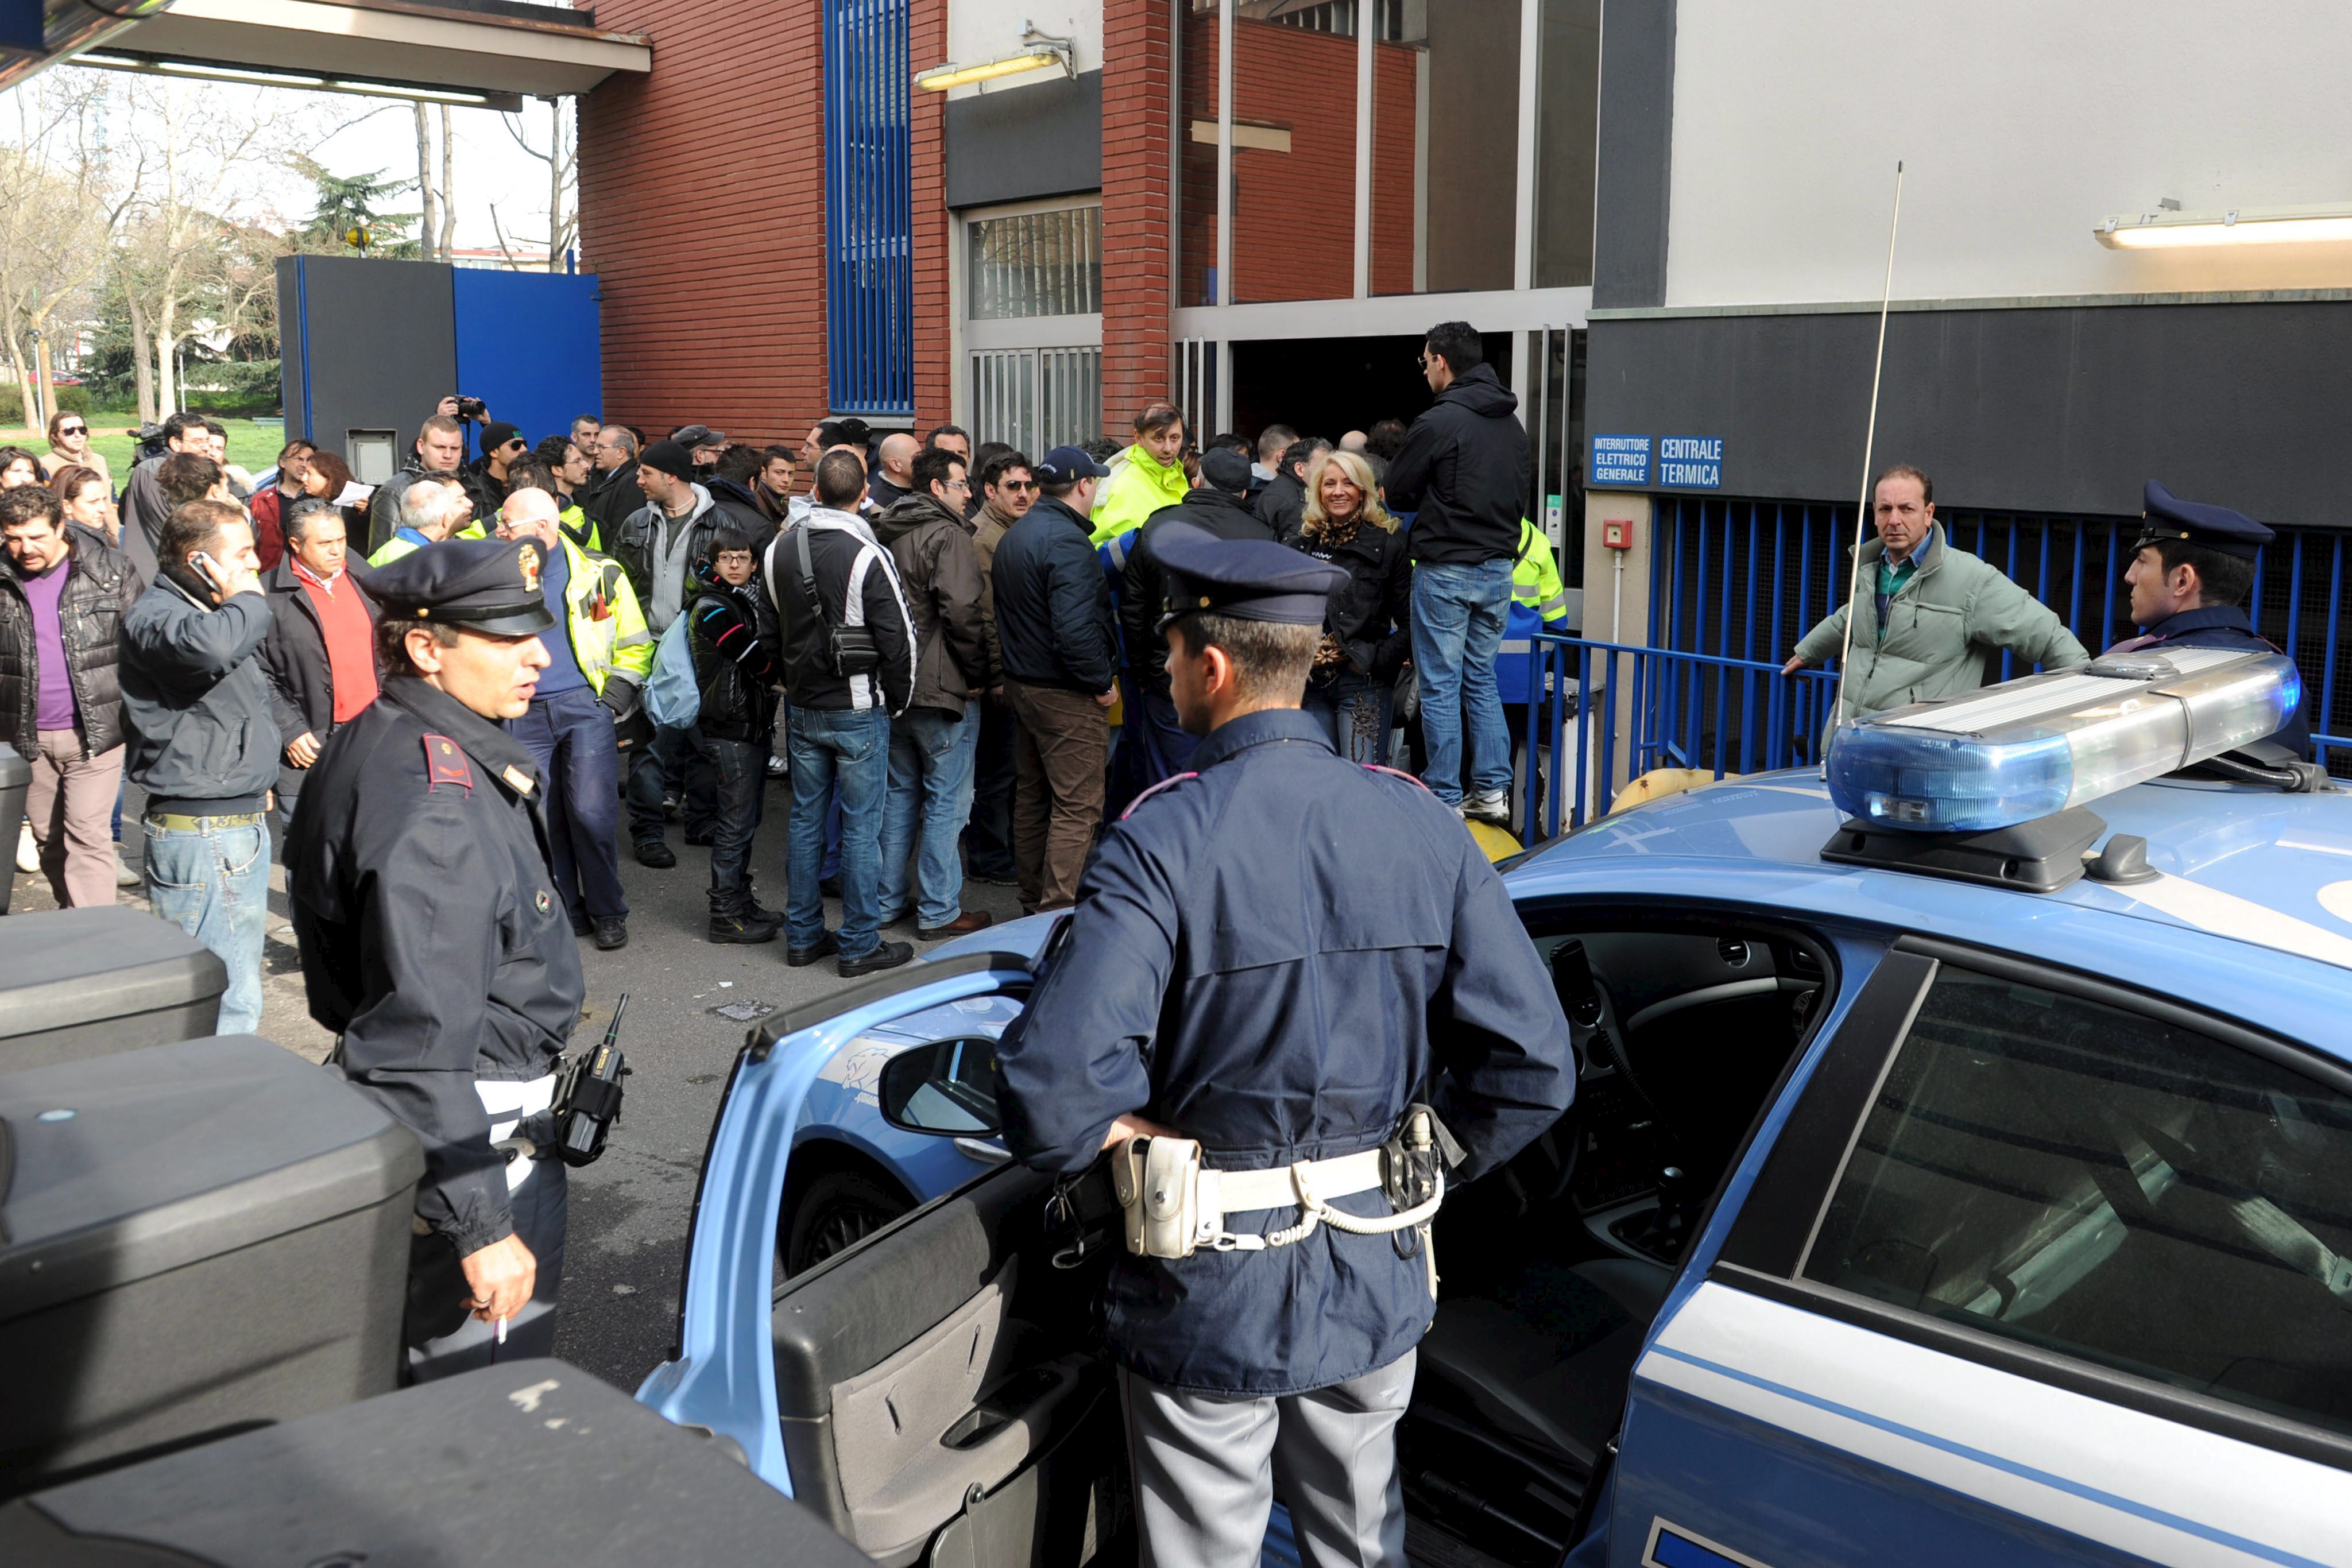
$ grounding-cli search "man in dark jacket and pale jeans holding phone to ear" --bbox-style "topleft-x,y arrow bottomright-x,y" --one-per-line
120,501 -> 285,1035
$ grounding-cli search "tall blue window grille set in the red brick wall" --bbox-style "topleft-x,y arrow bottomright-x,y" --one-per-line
826,0 -> 915,416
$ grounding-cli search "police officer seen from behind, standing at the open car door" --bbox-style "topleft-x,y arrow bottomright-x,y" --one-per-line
997,526 -> 1573,1568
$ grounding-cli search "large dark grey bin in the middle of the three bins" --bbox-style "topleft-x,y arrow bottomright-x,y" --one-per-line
0,1035 -> 423,1495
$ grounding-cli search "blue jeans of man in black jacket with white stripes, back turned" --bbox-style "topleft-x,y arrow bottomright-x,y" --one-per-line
786,707 -> 889,959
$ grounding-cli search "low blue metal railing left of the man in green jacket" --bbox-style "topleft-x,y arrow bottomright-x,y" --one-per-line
1519,635 -> 1837,842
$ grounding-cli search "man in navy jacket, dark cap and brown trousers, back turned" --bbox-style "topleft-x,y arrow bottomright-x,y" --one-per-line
990,447 -> 1120,910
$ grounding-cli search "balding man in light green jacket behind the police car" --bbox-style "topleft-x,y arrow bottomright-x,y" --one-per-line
1781,463 -> 2091,736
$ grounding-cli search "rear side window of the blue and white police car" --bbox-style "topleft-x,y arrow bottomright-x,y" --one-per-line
1804,964 -> 2352,1432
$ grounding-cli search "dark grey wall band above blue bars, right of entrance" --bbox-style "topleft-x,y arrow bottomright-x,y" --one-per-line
1585,301 -> 2352,526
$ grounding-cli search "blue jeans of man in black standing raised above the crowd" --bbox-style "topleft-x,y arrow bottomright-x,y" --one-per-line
1414,557 -> 1510,806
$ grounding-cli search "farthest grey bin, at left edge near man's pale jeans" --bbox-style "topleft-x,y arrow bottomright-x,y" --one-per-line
0,905 -> 228,1072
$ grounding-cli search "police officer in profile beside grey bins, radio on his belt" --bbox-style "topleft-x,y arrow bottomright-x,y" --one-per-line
285,541 -> 583,1377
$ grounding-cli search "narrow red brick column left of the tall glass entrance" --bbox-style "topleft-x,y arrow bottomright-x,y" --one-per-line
1103,0 -> 1174,440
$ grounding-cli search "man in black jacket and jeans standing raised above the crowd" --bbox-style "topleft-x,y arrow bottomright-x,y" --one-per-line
1386,322 -> 1529,823
